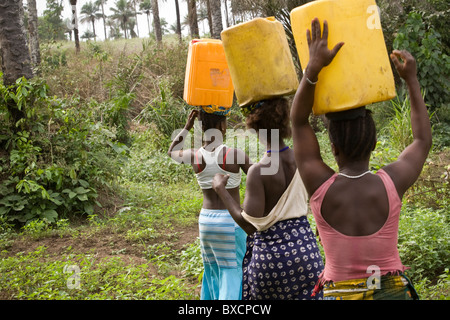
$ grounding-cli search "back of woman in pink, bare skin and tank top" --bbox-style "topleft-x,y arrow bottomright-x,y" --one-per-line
310,170 -> 405,281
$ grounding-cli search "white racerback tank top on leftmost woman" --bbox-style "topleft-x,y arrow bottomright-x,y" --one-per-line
195,144 -> 241,189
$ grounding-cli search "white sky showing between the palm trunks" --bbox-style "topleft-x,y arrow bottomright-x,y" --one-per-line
34,0 -> 209,40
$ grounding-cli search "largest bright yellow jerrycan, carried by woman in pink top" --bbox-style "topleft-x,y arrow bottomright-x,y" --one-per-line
291,0 -> 396,115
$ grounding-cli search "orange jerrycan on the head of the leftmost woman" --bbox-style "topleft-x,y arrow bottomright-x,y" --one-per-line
183,39 -> 234,108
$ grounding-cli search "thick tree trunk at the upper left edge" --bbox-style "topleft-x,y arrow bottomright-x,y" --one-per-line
0,0 -> 33,85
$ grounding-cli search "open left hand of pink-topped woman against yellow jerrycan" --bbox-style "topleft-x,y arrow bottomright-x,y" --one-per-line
306,18 -> 344,81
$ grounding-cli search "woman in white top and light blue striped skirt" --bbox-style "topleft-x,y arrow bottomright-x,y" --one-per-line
168,107 -> 252,300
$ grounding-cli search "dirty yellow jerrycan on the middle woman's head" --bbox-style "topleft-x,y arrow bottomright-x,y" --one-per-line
221,17 -> 299,107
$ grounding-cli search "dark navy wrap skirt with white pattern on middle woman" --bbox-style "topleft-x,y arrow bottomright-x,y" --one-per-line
242,216 -> 324,300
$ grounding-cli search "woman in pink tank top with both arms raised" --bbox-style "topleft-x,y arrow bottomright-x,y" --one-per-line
291,18 -> 432,300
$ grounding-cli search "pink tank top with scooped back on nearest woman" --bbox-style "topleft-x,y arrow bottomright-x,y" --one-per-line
310,170 -> 406,282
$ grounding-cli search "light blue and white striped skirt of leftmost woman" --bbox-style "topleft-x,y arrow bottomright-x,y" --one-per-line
199,209 -> 247,300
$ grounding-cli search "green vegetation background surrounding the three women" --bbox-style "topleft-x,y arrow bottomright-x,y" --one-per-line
0,0 -> 450,300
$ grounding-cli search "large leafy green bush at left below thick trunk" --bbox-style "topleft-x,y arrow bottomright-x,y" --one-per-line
0,78 -> 122,223
